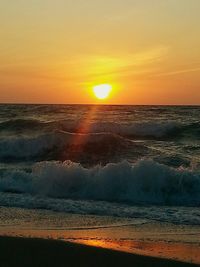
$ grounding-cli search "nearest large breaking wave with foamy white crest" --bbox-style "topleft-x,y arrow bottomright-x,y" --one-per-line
0,160 -> 200,206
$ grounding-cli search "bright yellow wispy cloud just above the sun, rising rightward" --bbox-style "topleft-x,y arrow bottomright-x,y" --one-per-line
75,46 -> 169,79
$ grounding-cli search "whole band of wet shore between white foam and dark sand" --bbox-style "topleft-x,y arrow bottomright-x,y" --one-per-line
0,207 -> 200,266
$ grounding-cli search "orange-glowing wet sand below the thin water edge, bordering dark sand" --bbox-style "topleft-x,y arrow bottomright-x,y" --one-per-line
0,224 -> 200,266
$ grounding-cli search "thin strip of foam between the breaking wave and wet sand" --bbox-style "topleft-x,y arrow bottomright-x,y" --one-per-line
0,197 -> 200,228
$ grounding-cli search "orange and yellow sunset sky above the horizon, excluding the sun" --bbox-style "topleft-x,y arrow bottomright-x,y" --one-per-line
0,0 -> 200,105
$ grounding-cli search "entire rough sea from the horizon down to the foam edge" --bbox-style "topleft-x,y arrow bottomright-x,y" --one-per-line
0,105 -> 200,225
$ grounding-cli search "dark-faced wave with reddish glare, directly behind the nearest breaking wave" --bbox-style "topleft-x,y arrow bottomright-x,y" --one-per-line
0,131 -> 147,161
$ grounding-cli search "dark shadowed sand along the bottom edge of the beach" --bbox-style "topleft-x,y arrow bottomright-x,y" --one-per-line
0,237 -> 197,267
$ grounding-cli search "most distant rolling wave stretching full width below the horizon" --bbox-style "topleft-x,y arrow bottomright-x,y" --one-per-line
0,119 -> 200,146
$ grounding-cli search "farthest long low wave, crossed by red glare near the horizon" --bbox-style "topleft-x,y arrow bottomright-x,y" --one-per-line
0,119 -> 197,139
